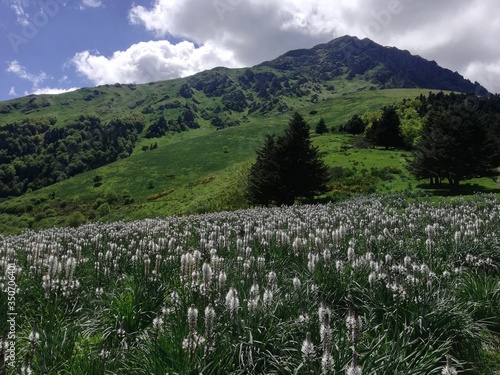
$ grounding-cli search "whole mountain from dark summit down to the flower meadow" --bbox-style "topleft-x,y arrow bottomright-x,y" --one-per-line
0,36 -> 487,233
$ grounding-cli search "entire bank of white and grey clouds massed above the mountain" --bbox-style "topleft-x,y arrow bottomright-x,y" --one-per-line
72,0 -> 500,92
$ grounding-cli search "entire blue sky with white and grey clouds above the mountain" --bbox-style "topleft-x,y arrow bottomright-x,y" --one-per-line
0,0 -> 500,101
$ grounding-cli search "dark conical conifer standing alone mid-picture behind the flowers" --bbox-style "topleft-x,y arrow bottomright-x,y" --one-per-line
248,112 -> 328,205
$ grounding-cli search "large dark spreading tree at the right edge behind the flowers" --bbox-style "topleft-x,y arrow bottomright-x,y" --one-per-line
410,103 -> 500,190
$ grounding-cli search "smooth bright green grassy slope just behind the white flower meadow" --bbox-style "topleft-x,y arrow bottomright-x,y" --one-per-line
0,86 -> 494,233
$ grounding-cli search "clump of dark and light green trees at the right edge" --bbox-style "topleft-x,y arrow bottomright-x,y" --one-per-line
340,92 -> 500,190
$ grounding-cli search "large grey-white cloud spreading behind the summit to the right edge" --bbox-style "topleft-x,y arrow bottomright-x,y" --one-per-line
129,0 -> 500,91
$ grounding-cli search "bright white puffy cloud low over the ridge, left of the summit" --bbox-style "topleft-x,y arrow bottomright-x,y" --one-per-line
72,40 -> 238,85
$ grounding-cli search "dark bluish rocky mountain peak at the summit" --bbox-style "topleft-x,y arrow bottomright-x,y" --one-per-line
260,35 -> 488,95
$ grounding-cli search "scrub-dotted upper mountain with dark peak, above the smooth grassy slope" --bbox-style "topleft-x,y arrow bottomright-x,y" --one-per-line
0,36 -> 488,127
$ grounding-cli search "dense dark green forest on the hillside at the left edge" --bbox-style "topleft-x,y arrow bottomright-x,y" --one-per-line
0,116 -> 144,197
